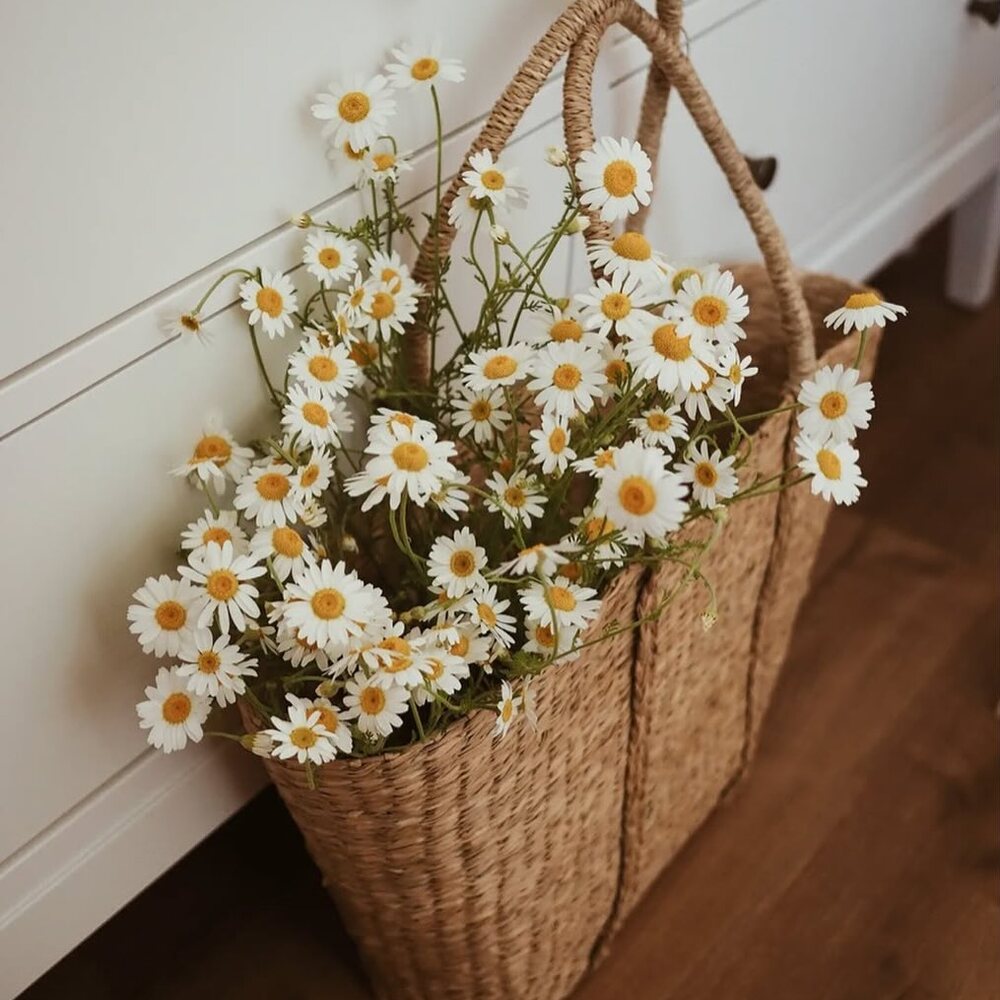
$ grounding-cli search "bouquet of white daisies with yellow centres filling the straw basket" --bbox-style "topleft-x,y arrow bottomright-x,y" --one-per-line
128,39 -> 905,769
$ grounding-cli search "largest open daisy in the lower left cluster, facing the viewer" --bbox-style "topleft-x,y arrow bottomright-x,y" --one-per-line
284,559 -> 386,656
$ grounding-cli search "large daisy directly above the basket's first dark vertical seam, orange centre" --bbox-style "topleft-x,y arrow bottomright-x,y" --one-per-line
597,441 -> 688,539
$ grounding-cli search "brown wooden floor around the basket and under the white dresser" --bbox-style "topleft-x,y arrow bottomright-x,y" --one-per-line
23,230 -> 1000,1000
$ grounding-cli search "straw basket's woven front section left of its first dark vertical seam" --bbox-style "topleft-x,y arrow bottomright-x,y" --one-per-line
248,568 -> 639,1000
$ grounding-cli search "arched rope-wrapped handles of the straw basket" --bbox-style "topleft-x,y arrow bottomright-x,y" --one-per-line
403,0 -> 816,386
